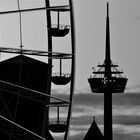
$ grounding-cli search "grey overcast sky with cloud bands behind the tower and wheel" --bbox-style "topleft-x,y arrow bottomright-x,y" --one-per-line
0,0 -> 140,140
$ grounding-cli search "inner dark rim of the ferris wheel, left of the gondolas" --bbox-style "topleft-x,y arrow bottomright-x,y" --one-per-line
42,0 -> 53,140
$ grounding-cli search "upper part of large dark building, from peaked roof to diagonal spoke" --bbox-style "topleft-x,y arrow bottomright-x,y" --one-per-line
0,55 -> 48,92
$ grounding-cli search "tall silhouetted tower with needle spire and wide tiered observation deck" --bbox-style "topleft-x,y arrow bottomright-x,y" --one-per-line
88,3 -> 127,140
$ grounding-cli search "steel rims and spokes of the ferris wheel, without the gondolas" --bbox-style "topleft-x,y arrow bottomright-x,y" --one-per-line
0,0 -> 75,140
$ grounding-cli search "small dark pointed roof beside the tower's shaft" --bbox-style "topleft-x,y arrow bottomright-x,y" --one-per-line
83,120 -> 104,140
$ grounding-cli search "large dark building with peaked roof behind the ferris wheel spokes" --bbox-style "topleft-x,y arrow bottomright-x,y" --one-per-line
0,55 -> 51,140
